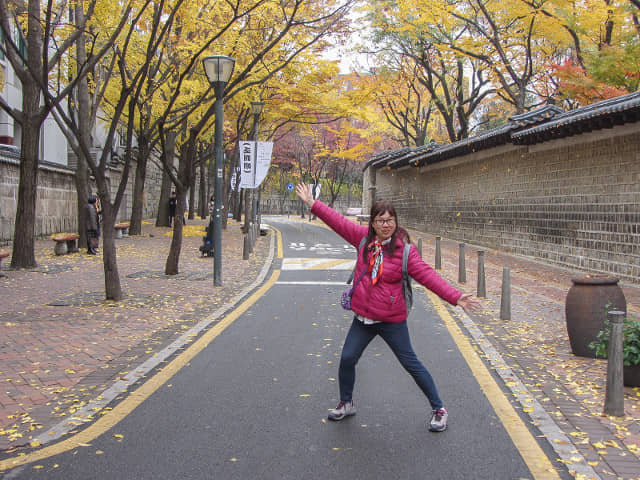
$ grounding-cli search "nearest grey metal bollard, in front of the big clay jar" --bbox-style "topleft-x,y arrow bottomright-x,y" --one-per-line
604,310 -> 625,417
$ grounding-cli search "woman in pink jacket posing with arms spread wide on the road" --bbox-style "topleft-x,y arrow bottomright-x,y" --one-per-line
296,183 -> 480,432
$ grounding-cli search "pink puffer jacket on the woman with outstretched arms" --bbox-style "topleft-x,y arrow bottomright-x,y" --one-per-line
311,200 -> 462,323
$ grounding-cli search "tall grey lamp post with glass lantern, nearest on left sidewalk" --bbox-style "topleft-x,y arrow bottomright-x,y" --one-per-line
202,55 -> 236,286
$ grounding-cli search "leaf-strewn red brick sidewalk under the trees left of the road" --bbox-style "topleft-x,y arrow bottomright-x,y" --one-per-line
0,220 -> 269,453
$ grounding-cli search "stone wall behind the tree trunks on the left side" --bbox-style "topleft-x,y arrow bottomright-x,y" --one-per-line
0,151 -> 162,244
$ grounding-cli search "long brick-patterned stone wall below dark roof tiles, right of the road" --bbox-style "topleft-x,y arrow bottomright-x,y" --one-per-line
372,123 -> 640,282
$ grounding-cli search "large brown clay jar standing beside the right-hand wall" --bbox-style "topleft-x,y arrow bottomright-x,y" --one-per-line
565,275 -> 627,358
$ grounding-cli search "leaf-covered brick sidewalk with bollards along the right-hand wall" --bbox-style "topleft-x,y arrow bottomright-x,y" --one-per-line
412,232 -> 640,479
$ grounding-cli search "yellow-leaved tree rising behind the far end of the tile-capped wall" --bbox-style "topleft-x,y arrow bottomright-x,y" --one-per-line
368,2 -> 493,142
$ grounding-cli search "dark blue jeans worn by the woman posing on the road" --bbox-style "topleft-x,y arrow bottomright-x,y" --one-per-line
338,318 -> 443,410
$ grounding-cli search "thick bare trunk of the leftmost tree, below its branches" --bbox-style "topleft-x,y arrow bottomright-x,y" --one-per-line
11,89 -> 42,268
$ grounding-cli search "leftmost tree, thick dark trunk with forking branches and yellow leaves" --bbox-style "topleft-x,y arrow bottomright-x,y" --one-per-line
0,0 -> 127,268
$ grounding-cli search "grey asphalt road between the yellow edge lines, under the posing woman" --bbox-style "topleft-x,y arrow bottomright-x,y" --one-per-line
0,220 -> 556,480
